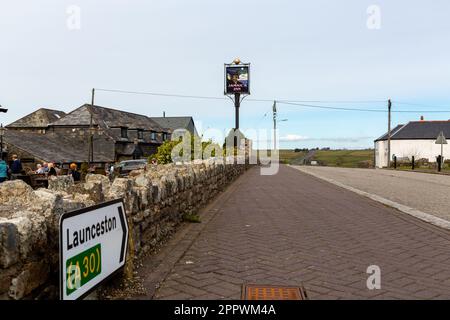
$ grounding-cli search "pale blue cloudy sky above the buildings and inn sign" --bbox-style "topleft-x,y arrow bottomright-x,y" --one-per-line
0,0 -> 450,149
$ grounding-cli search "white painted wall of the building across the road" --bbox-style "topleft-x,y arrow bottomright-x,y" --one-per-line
375,140 -> 450,168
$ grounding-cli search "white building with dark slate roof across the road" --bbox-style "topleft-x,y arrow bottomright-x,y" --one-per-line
375,120 -> 450,168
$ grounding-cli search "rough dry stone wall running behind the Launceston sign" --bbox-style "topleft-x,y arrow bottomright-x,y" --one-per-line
0,160 -> 247,299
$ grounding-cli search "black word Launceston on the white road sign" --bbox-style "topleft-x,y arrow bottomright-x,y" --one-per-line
67,216 -> 117,250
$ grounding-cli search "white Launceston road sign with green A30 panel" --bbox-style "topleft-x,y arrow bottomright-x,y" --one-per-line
59,199 -> 128,300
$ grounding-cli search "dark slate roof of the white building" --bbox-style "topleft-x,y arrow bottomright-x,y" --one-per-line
375,120 -> 450,142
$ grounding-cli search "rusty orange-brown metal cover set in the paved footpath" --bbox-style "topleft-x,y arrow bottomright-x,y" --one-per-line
242,284 -> 307,300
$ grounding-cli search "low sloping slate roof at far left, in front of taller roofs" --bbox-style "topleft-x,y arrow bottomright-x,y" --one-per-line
4,130 -> 114,163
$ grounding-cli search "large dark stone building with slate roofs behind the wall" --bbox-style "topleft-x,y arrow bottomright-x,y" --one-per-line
5,104 -> 172,170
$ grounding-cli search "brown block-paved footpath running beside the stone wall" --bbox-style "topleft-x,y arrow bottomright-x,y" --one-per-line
135,166 -> 450,299
